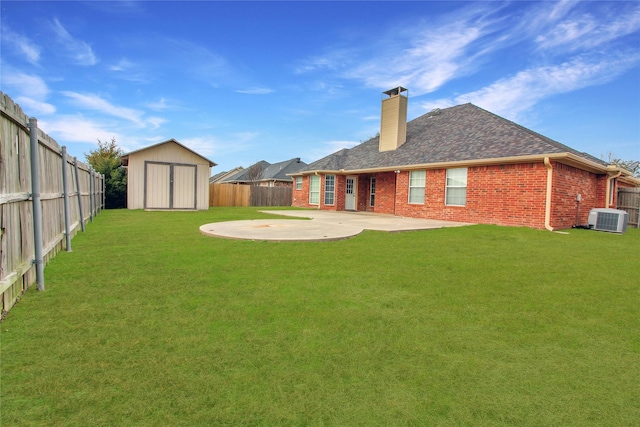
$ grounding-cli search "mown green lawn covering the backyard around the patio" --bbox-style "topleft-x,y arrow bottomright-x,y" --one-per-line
0,208 -> 640,426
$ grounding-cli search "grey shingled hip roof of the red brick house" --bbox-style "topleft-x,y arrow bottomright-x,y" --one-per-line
301,104 -> 608,173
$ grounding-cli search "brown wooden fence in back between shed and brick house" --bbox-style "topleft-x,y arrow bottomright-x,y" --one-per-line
209,184 -> 292,206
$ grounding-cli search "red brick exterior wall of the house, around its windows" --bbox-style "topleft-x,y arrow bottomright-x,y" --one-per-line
293,162 -> 617,229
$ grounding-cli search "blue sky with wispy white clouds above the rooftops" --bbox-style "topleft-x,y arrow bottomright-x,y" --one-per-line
0,0 -> 640,174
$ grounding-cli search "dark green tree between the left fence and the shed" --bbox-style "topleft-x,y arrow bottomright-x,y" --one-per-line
85,137 -> 127,209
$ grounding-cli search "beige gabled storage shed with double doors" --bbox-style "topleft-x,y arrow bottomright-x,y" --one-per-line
121,139 -> 216,210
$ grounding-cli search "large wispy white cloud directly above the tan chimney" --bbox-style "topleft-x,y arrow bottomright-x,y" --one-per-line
295,5 -> 504,95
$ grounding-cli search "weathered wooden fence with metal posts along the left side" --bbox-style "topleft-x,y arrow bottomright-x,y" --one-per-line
0,92 -> 104,317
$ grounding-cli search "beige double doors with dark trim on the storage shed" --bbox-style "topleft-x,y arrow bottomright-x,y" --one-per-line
144,162 -> 197,209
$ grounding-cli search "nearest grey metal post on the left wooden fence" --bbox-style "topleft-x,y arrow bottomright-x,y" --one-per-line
28,117 -> 44,291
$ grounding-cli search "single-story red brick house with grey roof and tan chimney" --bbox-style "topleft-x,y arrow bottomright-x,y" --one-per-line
291,87 -> 640,230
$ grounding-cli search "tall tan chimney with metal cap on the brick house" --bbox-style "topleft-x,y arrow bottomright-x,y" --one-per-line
378,86 -> 409,151
